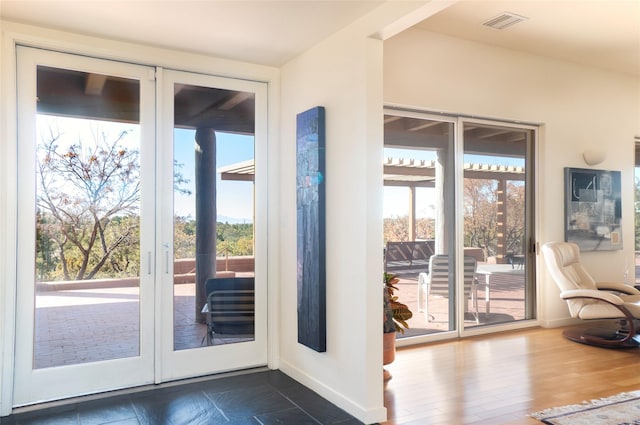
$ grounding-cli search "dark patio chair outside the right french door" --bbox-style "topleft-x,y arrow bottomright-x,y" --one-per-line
203,277 -> 255,344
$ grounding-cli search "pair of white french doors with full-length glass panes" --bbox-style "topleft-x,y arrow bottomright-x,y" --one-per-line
13,47 -> 267,406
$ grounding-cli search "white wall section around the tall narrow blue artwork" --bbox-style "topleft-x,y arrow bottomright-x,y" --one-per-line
279,19 -> 386,422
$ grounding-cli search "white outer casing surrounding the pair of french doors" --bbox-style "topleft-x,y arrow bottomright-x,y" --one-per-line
0,25 -> 281,416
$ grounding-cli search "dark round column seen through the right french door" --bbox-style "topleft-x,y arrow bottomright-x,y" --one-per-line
195,128 -> 217,323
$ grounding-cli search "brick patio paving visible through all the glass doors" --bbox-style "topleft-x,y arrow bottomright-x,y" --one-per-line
34,256 -> 640,368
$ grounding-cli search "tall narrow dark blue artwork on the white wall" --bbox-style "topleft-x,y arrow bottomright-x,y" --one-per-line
296,106 -> 327,352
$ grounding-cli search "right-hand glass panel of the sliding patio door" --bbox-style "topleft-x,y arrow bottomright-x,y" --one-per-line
463,122 -> 533,328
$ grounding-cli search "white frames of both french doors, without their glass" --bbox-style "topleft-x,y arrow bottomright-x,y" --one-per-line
11,47 -> 268,406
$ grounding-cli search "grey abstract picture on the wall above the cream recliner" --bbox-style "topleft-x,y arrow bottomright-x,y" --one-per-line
564,168 -> 622,251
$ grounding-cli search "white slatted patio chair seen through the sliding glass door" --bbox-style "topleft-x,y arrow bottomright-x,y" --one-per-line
418,255 -> 480,323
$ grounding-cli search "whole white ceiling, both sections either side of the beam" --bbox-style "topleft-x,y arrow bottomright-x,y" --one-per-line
0,0 -> 640,75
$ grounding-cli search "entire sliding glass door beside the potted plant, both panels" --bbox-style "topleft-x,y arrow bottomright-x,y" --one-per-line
384,110 -> 535,339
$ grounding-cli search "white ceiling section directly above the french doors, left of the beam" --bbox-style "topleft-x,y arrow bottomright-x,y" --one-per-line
0,0 -> 382,66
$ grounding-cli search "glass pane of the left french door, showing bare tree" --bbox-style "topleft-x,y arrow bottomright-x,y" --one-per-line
33,66 -> 141,369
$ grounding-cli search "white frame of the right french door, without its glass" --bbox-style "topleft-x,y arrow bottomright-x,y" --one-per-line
156,69 -> 267,382
